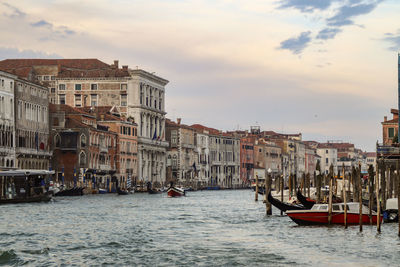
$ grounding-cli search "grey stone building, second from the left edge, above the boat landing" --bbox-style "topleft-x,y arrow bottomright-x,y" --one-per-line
15,78 -> 52,169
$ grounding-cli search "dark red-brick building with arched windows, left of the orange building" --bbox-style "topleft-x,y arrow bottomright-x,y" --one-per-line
50,104 -> 117,190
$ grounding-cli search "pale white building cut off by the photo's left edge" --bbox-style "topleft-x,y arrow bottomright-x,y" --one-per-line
0,71 -> 17,169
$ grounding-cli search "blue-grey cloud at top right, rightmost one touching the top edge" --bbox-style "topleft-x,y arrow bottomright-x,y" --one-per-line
326,0 -> 382,27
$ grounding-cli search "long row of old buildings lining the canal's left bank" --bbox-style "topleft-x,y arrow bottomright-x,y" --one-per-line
0,59 -> 375,188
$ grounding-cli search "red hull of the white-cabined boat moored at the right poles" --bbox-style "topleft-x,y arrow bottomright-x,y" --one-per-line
287,211 -> 382,225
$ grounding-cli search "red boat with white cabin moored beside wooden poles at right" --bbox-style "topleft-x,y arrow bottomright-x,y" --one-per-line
286,202 -> 382,225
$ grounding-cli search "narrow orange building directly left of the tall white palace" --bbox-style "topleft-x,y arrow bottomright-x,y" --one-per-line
80,106 -> 138,188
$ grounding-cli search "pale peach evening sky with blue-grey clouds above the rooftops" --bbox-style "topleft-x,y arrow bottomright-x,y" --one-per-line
0,0 -> 400,151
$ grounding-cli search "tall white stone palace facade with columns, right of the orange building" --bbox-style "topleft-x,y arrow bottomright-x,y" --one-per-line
127,69 -> 168,184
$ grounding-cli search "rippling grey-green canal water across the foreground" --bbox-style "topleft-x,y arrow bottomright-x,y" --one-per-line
0,190 -> 400,266
